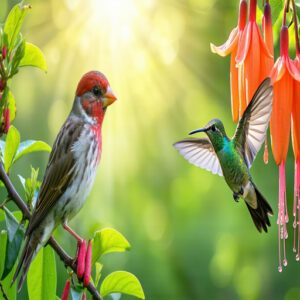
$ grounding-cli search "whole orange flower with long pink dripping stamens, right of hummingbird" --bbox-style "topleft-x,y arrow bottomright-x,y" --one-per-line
270,22 -> 300,272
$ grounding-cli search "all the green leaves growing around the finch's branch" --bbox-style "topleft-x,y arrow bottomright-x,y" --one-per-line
0,2 -> 144,300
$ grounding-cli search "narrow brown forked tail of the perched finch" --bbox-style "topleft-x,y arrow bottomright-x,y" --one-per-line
11,233 -> 41,292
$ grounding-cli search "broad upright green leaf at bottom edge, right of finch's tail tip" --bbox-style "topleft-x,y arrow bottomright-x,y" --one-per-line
27,246 -> 56,300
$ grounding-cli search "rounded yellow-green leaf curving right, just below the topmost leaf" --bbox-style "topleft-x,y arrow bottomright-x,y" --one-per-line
19,43 -> 48,72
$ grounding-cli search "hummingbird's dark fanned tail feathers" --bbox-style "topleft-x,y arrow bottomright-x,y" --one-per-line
246,184 -> 273,232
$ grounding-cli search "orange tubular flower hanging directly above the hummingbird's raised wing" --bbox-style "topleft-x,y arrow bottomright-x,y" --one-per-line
236,0 -> 273,116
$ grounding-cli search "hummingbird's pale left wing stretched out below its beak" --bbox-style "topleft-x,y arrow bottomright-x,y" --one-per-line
173,138 -> 223,176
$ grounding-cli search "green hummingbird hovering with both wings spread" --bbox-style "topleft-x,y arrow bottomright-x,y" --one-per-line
174,78 -> 273,232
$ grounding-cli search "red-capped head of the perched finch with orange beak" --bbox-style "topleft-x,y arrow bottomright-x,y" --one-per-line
76,71 -> 117,119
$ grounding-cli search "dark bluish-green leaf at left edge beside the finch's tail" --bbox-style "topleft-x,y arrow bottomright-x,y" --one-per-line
1,207 -> 24,280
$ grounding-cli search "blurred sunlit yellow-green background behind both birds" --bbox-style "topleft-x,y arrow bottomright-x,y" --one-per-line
0,0 -> 300,300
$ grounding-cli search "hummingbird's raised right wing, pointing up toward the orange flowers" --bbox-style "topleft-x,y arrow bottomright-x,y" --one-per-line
233,78 -> 273,168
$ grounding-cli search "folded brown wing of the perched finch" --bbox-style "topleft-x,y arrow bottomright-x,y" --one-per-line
26,120 -> 84,234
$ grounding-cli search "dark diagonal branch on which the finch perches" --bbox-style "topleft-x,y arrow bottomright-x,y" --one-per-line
0,162 -> 102,300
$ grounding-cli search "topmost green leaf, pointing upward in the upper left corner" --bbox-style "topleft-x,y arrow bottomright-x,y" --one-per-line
4,4 -> 31,50
